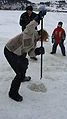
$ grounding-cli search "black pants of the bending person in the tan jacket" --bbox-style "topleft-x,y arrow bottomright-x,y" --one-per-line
4,47 -> 28,93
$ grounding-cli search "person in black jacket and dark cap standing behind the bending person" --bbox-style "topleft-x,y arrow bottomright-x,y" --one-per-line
20,5 -> 37,60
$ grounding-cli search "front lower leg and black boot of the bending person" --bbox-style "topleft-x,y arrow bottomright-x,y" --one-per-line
9,75 -> 23,102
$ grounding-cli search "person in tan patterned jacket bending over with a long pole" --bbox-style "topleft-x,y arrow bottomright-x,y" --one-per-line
4,9 -> 46,102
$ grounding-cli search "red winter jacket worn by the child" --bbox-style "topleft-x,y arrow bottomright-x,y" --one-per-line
52,27 -> 66,44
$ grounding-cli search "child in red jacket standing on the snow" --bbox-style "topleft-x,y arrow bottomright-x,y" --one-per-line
51,21 -> 66,56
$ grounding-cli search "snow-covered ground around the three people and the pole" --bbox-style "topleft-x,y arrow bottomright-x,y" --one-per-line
0,11 -> 67,119
